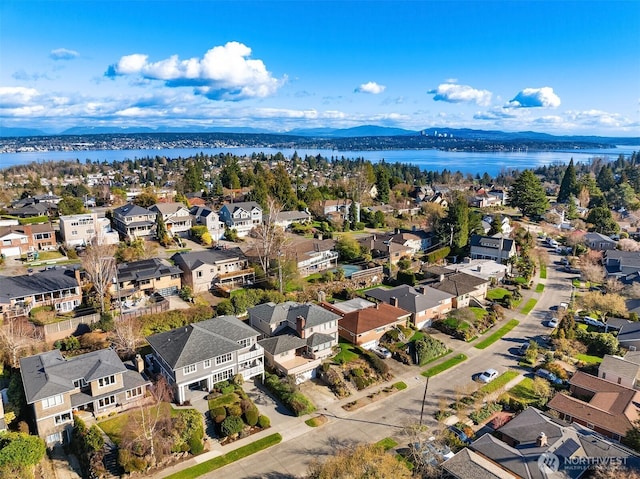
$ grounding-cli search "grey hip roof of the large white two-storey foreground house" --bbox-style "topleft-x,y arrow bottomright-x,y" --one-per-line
147,316 -> 258,369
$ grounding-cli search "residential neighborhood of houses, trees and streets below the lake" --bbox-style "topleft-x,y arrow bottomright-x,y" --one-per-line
0,150 -> 640,479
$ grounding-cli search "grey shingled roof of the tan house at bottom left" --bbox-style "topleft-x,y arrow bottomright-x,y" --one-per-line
20,349 -> 126,404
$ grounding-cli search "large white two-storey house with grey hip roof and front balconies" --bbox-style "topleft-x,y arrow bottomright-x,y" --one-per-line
147,316 -> 264,404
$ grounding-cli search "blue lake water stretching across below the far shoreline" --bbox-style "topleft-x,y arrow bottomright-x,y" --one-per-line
0,145 -> 640,176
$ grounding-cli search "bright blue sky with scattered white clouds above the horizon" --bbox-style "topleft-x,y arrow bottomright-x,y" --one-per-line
0,0 -> 640,136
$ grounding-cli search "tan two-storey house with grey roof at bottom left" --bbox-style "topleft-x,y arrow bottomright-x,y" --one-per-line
20,349 -> 150,447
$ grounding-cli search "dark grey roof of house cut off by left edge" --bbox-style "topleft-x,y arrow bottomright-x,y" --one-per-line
0,268 -> 79,303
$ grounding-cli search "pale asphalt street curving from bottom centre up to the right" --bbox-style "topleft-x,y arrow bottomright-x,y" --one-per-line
203,246 -> 571,479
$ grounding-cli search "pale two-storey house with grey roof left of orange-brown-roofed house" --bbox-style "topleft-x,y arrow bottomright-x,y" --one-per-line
249,301 -> 340,382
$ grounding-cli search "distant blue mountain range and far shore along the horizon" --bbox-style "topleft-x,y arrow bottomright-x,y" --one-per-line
0,125 -> 640,145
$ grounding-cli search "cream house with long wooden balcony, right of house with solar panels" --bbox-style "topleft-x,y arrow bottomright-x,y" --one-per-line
171,248 -> 256,293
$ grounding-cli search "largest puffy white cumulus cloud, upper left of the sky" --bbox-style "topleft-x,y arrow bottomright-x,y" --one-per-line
105,42 -> 286,101
